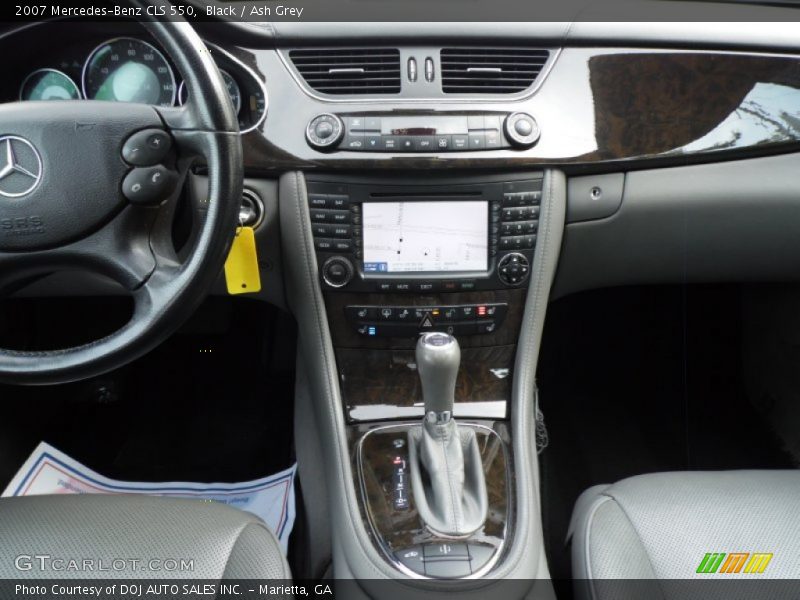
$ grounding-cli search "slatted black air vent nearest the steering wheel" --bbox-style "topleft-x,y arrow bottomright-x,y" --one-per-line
289,48 -> 400,95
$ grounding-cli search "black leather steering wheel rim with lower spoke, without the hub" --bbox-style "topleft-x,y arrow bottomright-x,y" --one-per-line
0,0 -> 243,384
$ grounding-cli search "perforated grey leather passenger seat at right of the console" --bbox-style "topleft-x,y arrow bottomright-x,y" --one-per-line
570,471 -> 800,598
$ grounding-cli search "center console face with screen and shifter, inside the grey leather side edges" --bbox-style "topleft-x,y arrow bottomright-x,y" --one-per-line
306,172 -> 543,578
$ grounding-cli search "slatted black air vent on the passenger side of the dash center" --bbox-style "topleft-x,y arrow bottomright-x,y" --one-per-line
441,48 -> 550,94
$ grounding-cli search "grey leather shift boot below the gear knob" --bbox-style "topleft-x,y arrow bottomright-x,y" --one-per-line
408,419 -> 489,537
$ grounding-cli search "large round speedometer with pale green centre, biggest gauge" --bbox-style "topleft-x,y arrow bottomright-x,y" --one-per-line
82,38 -> 176,106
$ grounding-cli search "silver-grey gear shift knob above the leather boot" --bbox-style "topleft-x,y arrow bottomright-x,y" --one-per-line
416,332 -> 461,422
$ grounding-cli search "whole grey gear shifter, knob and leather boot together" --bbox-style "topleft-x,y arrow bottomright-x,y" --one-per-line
409,332 -> 488,537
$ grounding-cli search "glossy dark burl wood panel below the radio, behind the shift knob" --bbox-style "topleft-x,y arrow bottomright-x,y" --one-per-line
325,288 -> 527,421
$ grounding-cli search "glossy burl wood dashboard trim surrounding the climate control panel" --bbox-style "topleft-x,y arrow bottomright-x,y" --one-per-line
243,47 -> 800,172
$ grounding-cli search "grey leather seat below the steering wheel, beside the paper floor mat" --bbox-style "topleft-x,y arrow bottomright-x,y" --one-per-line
0,495 -> 291,580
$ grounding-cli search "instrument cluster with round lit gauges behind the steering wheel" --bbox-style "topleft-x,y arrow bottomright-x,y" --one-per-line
13,36 -> 267,133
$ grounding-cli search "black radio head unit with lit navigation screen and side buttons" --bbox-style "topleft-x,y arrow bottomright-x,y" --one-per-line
308,176 -> 542,293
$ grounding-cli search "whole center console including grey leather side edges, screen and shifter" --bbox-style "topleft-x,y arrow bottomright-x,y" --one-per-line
280,166 -> 566,597
